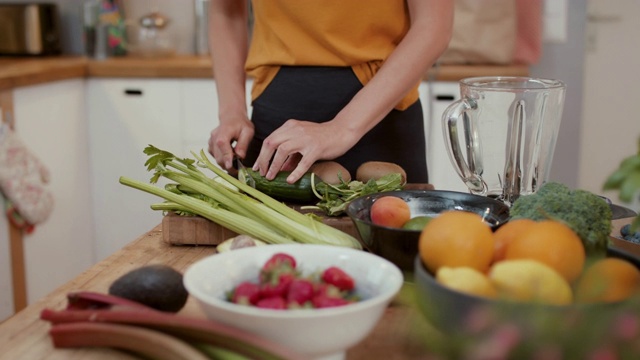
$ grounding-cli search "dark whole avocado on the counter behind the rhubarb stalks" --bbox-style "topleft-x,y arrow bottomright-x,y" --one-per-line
109,264 -> 189,312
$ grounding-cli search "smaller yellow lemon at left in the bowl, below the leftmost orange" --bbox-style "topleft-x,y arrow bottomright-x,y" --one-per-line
436,266 -> 497,298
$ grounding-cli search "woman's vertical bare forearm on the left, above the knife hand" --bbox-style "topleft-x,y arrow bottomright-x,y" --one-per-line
209,0 -> 249,123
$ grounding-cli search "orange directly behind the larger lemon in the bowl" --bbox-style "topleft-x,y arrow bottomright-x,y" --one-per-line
504,220 -> 586,283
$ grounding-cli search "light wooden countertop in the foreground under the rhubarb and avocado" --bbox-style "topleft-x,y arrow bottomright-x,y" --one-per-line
0,225 -> 434,360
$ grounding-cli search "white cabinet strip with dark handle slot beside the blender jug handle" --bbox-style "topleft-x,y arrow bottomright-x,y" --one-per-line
420,81 -> 469,192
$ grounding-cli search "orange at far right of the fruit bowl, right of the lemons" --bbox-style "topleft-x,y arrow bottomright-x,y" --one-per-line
576,258 -> 640,302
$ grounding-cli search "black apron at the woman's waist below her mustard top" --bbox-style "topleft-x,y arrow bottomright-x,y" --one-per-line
245,66 -> 428,183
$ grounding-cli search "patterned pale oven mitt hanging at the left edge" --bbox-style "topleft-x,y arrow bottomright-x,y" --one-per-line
0,124 -> 53,229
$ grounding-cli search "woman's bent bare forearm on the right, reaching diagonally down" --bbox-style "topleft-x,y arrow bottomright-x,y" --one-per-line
334,0 -> 453,137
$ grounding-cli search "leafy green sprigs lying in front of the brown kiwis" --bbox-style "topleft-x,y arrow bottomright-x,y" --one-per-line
312,173 -> 404,216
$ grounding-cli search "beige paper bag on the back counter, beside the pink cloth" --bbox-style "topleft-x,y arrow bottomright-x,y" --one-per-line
438,0 -> 517,64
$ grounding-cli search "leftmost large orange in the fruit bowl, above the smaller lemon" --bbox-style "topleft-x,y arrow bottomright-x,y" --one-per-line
418,210 -> 493,274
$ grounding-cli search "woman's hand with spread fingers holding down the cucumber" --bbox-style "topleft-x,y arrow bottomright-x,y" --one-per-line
253,119 -> 360,184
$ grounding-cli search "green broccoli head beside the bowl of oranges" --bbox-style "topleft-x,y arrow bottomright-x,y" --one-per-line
510,182 -> 612,256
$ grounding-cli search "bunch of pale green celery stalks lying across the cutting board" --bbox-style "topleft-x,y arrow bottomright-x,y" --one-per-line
120,145 -> 362,249
